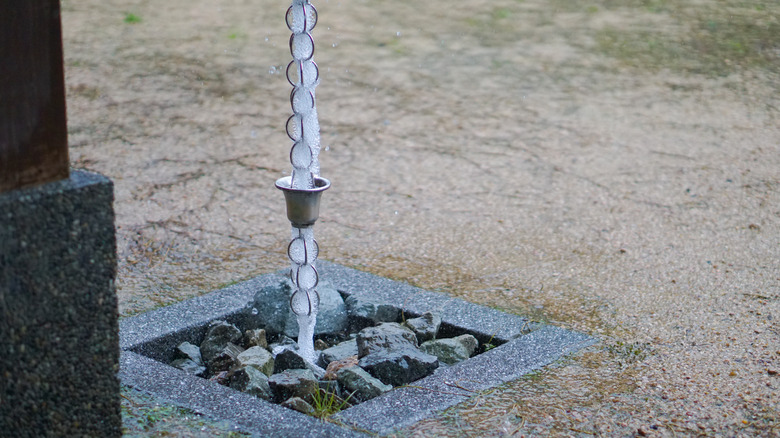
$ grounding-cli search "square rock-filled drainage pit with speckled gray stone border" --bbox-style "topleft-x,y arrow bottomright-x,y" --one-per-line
120,261 -> 595,437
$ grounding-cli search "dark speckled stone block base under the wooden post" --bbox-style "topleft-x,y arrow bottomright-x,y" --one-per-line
0,171 -> 122,437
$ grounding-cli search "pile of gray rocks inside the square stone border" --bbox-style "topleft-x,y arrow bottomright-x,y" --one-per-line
171,280 -> 478,414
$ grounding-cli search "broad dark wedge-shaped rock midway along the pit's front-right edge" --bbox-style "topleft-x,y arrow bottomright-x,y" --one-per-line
358,348 -> 439,386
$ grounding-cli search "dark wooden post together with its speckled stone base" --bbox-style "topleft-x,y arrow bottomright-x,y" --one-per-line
0,0 -> 122,438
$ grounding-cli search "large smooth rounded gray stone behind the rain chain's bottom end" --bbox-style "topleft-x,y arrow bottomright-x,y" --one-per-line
249,277 -> 347,338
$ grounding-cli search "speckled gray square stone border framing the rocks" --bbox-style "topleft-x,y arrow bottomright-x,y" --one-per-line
119,261 -> 596,437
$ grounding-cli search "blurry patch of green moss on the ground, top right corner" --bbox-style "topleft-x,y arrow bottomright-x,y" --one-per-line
595,1 -> 780,76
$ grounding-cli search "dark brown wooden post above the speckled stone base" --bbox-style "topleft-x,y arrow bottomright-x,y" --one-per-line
0,0 -> 69,193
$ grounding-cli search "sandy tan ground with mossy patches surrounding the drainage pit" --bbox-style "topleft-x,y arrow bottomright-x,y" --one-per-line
62,0 -> 780,436
